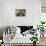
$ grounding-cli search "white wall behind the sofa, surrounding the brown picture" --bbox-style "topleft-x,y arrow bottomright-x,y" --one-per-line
2,0 -> 40,26
